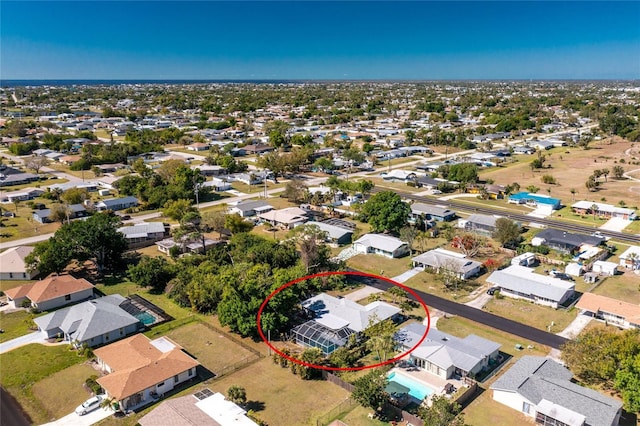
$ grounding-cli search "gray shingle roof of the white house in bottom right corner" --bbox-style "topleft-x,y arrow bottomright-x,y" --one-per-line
491,355 -> 622,426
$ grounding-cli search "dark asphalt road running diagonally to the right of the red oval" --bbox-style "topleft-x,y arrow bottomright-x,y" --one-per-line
353,276 -> 567,349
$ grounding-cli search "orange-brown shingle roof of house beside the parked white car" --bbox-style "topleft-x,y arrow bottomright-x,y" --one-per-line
94,334 -> 199,400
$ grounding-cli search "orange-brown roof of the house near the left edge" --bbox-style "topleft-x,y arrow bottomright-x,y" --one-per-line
5,275 -> 93,303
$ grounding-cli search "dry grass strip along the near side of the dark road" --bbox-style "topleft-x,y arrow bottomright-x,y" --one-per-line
436,317 -> 549,358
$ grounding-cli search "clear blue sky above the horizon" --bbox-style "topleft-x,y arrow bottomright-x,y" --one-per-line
0,0 -> 640,79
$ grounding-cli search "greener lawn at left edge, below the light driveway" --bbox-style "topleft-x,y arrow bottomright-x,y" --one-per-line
0,344 -> 85,424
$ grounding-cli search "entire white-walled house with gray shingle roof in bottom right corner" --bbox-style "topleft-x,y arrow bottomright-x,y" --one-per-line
490,355 -> 622,426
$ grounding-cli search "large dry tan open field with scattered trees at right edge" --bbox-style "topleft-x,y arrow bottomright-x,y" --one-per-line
480,138 -> 640,206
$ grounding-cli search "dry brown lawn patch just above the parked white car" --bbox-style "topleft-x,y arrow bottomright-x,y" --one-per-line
32,363 -> 99,420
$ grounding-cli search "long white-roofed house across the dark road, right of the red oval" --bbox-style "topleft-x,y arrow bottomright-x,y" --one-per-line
487,265 -> 575,308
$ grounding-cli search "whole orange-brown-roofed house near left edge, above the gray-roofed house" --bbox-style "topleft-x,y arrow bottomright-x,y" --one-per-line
5,275 -> 93,311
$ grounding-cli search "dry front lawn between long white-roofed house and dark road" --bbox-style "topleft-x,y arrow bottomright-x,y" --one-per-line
485,297 -> 578,333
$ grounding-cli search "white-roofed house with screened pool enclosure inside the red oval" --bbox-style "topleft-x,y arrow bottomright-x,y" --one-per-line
291,293 -> 400,355
